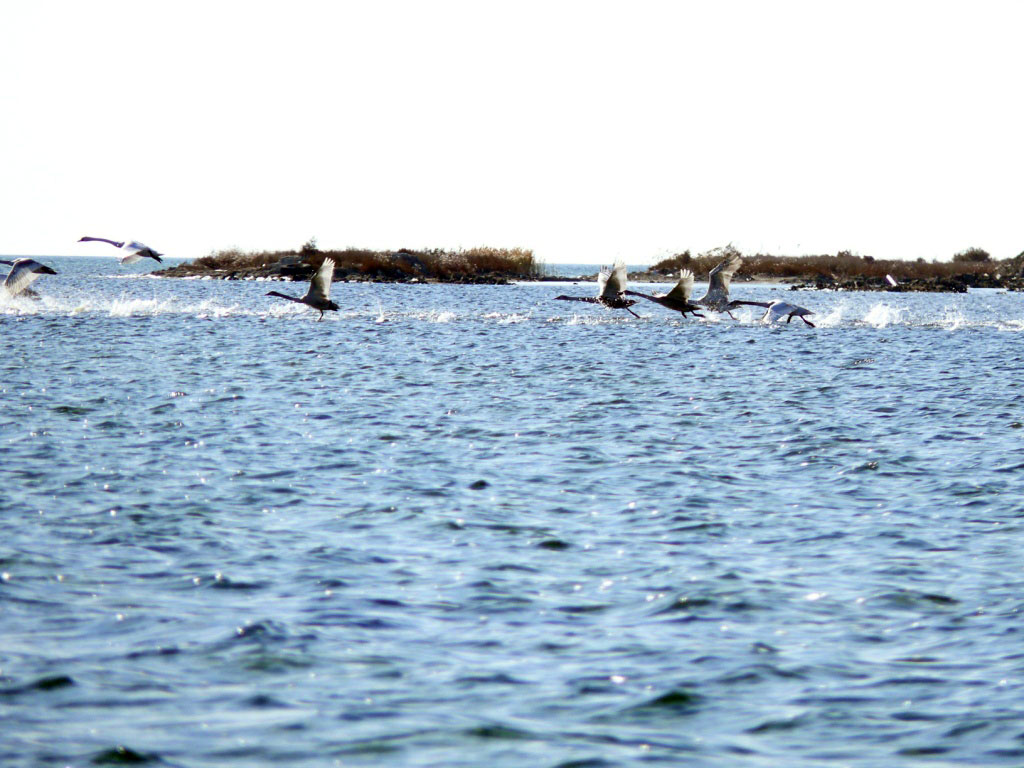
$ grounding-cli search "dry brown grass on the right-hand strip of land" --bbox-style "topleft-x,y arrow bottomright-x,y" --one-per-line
651,246 -> 997,281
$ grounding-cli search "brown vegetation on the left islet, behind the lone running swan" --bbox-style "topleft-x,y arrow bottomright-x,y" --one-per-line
160,238 -> 542,283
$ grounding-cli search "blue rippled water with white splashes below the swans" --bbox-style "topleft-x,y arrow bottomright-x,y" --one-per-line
0,258 -> 1024,768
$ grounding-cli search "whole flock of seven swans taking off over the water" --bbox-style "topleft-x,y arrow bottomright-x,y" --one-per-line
0,237 -> 814,328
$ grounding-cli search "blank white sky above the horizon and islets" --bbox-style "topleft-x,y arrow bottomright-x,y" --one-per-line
0,0 -> 1024,264
